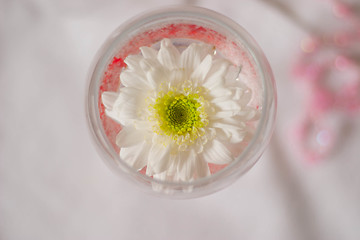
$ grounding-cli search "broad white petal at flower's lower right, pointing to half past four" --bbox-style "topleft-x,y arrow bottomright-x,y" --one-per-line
202,139 -> 233,164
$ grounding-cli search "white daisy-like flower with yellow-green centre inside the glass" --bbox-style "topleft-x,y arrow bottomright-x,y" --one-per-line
102,39 -> 257,181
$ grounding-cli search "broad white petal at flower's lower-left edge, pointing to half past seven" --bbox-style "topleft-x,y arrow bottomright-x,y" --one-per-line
120,141 -> 150,170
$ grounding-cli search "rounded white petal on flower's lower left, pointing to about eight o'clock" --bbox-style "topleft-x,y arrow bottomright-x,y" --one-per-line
116,126 -> 146,147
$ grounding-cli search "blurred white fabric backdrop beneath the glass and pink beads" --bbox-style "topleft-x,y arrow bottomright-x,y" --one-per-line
0,0 -> 360,240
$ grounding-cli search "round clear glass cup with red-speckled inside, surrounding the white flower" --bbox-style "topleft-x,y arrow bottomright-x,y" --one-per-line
87,7 -> 276,198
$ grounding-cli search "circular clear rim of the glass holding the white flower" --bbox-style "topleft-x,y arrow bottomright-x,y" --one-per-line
86,5 -> 277,195
